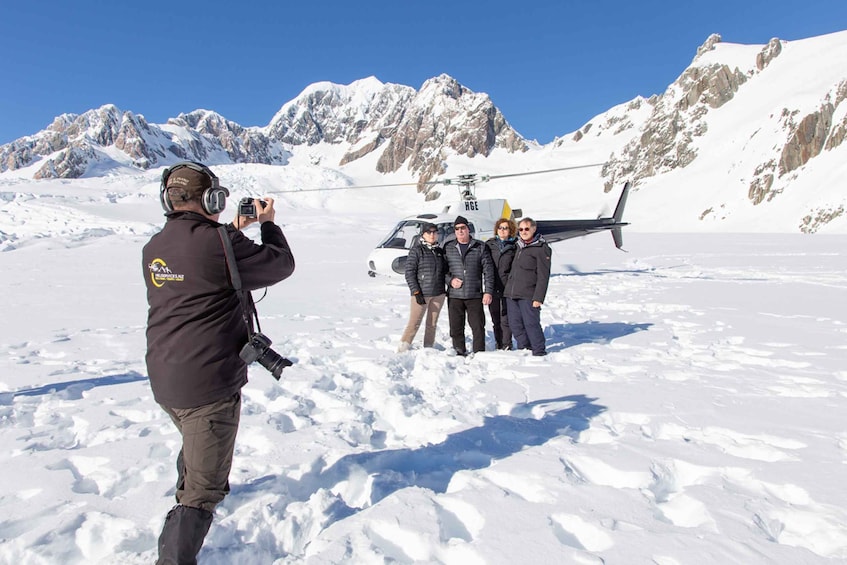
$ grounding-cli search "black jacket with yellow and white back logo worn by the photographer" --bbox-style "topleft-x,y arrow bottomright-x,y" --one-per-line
142,211 -> 294,408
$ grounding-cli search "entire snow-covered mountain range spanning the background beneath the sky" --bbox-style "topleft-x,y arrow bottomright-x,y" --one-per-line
0,28 -> 847,232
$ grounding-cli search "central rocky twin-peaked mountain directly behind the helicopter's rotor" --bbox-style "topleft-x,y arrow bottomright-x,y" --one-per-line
268,75 -> 527,191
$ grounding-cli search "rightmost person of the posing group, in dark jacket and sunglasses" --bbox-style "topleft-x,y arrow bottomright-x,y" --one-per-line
504,218 -> 553,356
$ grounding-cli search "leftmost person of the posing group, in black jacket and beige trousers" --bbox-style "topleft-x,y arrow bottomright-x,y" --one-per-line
397,223 -> 447,353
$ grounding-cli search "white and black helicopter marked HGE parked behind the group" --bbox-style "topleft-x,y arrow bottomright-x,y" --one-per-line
367,165 -> 630,277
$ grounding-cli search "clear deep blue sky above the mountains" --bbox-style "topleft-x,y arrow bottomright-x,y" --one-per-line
0,0 -> 847,144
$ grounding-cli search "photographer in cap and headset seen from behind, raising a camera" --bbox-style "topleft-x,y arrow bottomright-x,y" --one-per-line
143,161 -> 294,564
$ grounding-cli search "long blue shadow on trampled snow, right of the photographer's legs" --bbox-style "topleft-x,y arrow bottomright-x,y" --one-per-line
289,395 -> 606,508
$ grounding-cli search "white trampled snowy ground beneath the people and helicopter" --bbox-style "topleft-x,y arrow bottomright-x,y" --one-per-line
0,183 -> 847,565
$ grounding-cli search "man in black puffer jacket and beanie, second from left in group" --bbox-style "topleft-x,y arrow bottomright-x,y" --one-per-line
444,216 -> 494,355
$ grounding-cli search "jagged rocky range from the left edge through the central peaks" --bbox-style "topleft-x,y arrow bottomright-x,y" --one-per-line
0,75 -> 527,183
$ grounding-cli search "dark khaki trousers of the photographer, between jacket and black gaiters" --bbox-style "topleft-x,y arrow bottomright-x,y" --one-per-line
162,393 -> 241,512
